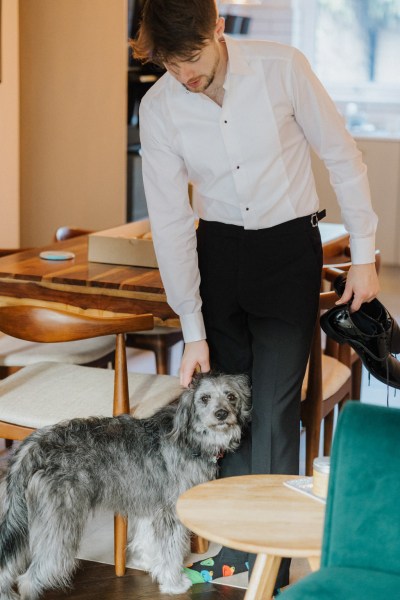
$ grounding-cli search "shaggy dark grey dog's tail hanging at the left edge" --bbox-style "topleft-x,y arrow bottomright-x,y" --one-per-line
0,439 -> 41,568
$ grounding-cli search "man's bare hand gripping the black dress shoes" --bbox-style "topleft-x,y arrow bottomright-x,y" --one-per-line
336,263 -> 379,312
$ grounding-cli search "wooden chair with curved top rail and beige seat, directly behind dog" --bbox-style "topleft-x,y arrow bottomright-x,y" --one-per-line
0,304 -> 181,576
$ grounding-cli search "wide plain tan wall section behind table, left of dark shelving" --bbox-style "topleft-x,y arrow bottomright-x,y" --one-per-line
18,0 -> 127,246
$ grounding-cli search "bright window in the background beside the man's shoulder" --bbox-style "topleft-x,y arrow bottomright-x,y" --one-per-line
293,0 -> 400,136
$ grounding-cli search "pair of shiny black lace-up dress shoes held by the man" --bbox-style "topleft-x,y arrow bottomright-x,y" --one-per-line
321,282 -> 400,389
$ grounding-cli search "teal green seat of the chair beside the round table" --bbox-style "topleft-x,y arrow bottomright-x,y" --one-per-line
282,567 -> 400,600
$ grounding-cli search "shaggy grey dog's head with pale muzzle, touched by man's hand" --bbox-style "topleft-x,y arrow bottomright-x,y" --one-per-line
171,373 -> 251,452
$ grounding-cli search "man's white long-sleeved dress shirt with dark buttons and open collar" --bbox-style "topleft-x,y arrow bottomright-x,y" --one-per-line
140,36 -> 377,342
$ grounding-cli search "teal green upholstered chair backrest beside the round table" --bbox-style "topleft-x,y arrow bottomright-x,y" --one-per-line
321,402 -> 400,574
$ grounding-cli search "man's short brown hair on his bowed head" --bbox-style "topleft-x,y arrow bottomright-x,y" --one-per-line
130,0 -> 218,66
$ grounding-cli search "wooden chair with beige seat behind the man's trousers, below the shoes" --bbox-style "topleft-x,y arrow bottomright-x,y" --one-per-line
300,292 -> 352,475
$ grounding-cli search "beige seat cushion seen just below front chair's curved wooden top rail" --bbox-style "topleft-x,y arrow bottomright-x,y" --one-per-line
0,333 -> 115,367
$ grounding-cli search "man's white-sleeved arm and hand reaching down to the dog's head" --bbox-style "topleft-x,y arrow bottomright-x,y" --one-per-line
140,94 -> 210,386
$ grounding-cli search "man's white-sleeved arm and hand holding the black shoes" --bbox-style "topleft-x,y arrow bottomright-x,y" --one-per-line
291,52 -> 379,311
